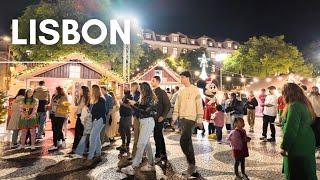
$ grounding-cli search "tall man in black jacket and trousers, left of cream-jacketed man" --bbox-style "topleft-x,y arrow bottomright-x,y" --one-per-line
151,76 -> 171,163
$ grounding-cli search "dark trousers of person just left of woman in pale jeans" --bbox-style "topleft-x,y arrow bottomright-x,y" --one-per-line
119,116 -> 132,146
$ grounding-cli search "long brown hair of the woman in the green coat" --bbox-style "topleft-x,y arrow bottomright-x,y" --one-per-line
282,83 -> 316,119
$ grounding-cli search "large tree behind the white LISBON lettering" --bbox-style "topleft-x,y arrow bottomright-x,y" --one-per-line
12,0 -> 143,72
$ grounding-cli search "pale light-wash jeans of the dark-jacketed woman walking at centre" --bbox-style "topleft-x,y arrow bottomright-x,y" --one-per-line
132,117 -> 155,167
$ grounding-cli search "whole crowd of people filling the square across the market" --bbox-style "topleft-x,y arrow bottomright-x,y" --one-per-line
7,71 -> 320,179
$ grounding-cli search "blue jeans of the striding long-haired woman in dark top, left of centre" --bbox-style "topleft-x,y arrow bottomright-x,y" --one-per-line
75,118 -> 104,160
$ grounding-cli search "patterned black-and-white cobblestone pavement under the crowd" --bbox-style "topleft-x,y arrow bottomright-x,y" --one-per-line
0,118 -> 320,180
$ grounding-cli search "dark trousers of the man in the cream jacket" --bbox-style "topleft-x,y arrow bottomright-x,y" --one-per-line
180,119 -> 196,165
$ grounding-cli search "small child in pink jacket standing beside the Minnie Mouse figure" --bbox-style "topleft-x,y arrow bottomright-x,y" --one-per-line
210,105 -> 224,143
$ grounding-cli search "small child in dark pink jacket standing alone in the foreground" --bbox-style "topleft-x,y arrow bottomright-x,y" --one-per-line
227,118 -> 251,179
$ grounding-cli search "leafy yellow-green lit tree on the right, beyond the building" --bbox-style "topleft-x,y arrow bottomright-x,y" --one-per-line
223,35 -> 312,78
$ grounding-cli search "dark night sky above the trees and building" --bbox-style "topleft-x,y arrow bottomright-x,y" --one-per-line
0,0 -> 320,48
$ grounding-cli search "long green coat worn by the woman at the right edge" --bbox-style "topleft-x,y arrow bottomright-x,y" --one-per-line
281,102 -> 317,180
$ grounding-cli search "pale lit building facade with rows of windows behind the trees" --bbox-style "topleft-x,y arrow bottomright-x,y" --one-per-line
143,30 -> 239,59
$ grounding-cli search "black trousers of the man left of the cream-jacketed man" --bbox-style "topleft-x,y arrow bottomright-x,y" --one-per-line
153,120 -> 167,159
